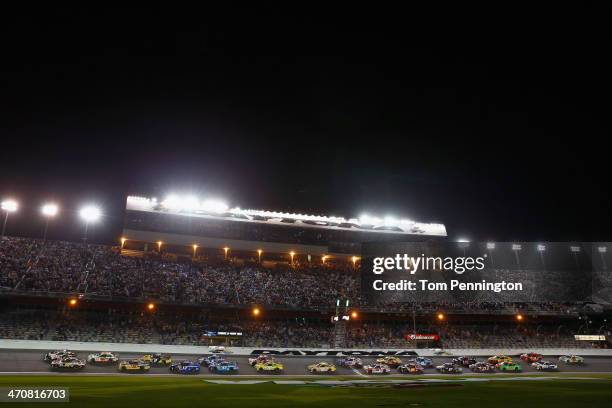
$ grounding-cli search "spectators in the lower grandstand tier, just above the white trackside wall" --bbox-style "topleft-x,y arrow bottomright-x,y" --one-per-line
0,308 -> 611,349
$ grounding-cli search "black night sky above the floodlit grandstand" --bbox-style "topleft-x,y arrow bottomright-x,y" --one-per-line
0,3 -> 612,240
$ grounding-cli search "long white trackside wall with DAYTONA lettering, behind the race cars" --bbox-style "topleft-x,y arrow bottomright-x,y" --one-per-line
0,339 -> 612,357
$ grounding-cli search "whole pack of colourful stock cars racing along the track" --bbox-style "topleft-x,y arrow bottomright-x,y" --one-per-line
43,350 -> 584,375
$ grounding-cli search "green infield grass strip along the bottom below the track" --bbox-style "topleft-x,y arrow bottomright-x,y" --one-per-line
0,374 -> 612,408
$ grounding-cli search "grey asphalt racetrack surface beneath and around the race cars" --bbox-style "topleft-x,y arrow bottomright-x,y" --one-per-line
0,350 -> 612,378
